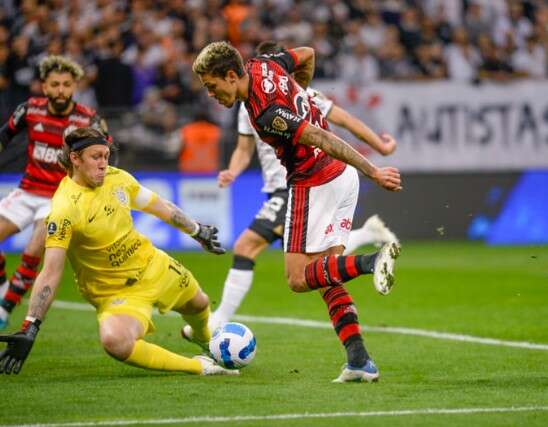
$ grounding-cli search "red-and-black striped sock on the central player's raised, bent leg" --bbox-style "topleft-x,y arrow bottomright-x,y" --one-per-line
304,253 -> 377,289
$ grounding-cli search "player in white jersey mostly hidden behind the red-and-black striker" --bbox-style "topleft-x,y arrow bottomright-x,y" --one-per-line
206,42 -> 397,335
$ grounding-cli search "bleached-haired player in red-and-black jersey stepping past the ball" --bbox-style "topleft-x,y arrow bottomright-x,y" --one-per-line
193,42 -> 401,382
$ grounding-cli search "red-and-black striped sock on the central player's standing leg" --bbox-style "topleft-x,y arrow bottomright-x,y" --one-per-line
322,286 -> 369,368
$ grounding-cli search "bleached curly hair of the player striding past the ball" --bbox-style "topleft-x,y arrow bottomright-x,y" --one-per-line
192,42 -> 244,78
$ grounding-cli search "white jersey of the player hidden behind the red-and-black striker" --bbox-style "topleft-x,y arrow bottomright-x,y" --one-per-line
238,88 -> 333,193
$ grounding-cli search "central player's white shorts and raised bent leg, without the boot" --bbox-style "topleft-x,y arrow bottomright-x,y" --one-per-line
284,167 -> 391,292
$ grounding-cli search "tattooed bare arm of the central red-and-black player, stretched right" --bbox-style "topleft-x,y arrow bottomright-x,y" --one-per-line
298,122 -> 401,191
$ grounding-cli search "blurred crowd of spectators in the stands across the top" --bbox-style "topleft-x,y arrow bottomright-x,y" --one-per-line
0,0 -> 548,166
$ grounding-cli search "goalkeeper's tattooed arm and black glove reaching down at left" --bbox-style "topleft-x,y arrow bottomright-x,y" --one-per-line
0,247 -> 66,374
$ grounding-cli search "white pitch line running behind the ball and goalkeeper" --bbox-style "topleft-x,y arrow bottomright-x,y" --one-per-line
53,301 -> 548,351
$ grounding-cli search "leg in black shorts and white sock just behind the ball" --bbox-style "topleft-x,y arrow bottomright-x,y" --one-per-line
209,189 -> 288,330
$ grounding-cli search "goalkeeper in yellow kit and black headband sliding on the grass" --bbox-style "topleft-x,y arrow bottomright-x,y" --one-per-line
0,128 -> 238,375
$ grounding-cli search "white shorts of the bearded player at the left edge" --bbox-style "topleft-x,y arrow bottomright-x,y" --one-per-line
0,188 -> 51,230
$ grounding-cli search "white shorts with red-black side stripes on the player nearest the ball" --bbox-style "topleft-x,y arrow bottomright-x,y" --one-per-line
284,166 -> 360,253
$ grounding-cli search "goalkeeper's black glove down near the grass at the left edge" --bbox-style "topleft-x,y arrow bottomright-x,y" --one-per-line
0,319 -> 41,375
